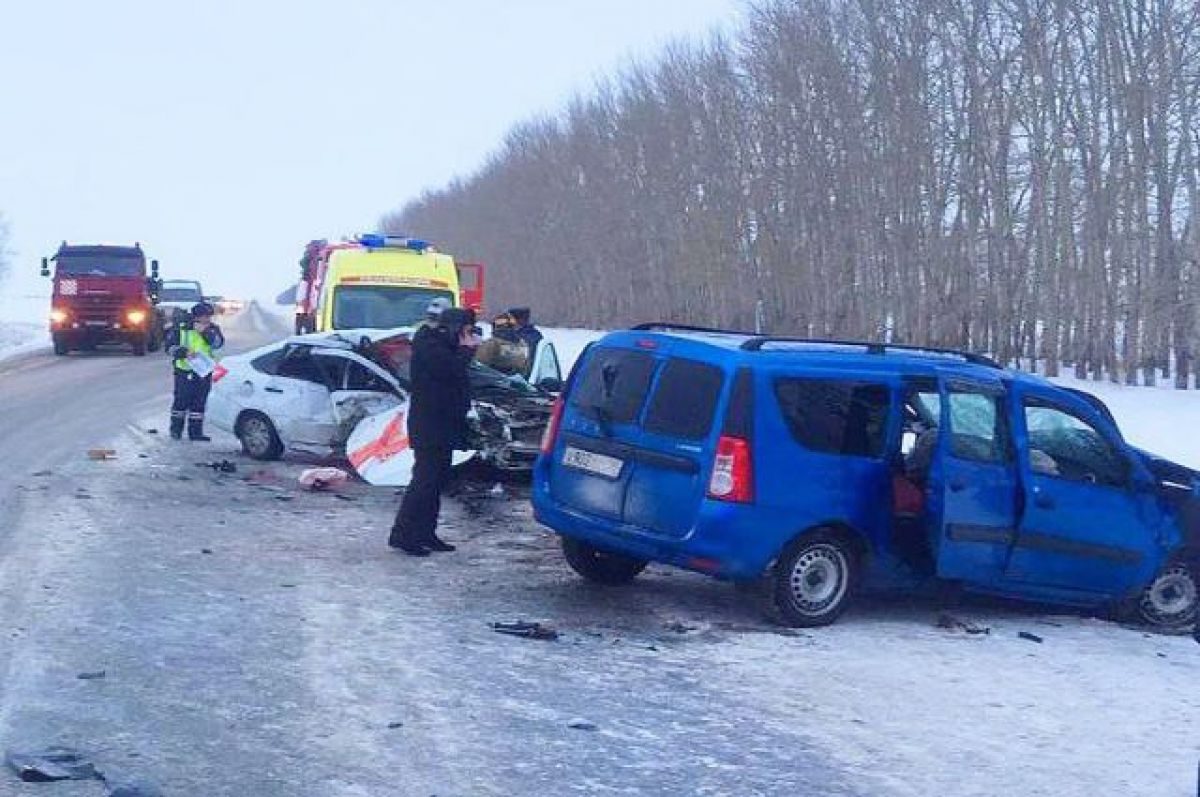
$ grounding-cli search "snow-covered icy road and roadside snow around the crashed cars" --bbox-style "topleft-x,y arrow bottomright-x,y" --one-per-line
0,316 -> 1200,797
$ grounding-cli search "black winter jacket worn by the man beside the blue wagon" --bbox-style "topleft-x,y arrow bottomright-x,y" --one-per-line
408,326 -> 472,449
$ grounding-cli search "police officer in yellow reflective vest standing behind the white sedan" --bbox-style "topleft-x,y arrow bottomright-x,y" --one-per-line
168,301 -> 224,441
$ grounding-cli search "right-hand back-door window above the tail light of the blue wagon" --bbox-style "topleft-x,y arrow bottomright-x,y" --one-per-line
643,359 -> 725,441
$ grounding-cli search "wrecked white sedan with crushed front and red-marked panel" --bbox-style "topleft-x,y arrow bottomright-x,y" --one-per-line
208,329 -> 562,485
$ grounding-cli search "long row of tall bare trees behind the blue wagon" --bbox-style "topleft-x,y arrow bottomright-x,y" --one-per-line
385,0 -> 1200,388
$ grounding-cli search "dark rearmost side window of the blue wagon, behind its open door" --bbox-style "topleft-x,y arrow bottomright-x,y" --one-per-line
775,378 -> 890,457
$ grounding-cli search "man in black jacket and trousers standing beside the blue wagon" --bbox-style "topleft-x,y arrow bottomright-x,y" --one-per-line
388,307 -> 479,556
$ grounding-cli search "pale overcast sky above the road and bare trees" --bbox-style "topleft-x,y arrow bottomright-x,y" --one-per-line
0,0 -> 742,319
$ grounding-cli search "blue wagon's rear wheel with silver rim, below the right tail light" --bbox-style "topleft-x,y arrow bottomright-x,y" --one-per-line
768,531 -> 860,628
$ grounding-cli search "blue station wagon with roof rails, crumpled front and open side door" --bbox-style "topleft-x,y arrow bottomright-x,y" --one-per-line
533,324 -> 1200,628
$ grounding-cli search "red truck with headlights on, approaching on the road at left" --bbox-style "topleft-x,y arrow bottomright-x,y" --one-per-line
42,241 -> 162,355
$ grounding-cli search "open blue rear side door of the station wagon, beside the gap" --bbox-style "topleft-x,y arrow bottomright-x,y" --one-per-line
930,379 -> 1018,585
